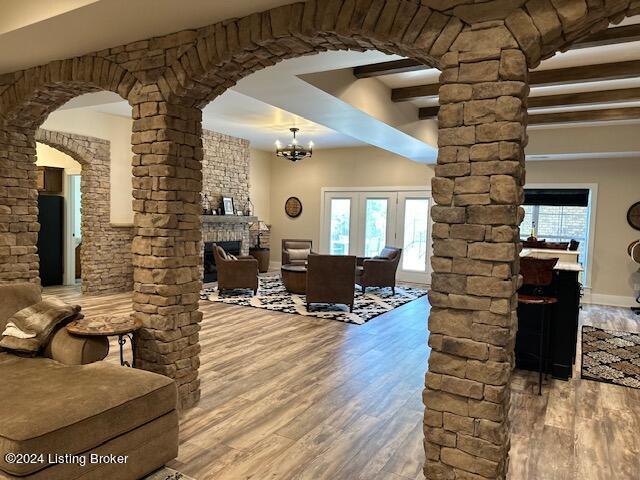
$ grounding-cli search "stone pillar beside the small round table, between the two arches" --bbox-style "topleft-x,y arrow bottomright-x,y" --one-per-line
132,87 -> 202,408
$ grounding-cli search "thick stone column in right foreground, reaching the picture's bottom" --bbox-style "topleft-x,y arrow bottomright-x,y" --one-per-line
424,26 -> 528,480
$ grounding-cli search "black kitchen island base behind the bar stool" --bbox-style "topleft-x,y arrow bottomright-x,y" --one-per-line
516,270 -> 580,380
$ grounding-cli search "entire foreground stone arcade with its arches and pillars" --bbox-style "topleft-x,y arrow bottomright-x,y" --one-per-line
0,0 -> 640,472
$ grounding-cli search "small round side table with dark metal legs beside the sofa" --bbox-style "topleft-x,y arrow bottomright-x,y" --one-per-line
67,315 -> 142,368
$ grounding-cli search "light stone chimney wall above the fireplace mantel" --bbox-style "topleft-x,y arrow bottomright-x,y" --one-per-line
202,130 -> 250,213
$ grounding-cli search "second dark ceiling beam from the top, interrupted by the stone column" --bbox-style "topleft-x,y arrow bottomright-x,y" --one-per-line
391,60 -> 640,102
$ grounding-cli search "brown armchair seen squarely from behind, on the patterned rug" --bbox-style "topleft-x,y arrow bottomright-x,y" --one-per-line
306,255 -> 356,312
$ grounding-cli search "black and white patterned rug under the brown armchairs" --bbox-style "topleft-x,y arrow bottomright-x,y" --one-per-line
200,275 -> 427,325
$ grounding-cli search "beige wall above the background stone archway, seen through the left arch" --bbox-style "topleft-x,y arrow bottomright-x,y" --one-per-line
42,109 -> 133,224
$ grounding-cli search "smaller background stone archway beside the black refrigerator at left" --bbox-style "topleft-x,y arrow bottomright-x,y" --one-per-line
35,129 -> 133,294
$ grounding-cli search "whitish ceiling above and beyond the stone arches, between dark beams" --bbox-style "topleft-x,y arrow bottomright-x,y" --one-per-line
10,0 -> 640,162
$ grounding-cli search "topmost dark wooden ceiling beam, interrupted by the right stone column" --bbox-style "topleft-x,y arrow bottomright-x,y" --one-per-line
353,23 -> 640,78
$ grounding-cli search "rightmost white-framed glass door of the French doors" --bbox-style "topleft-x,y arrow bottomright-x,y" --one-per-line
396,191 -> 431,283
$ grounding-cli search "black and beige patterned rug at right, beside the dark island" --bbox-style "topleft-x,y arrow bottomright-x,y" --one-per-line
582,325 -> 640,388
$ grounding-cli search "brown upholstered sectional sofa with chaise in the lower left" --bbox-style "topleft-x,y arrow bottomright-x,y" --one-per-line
0,284 -> 178,480
